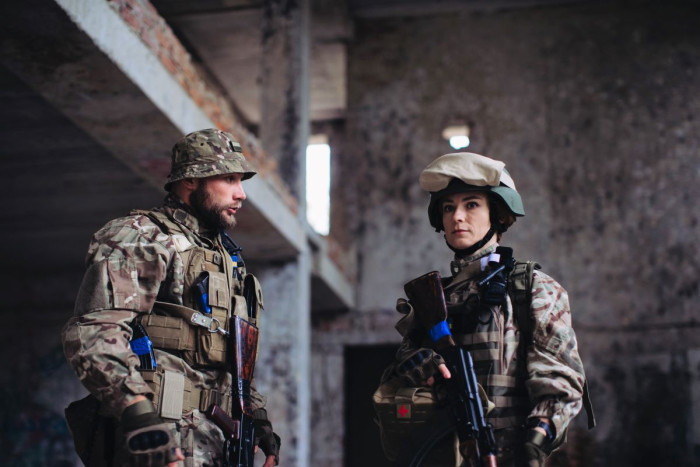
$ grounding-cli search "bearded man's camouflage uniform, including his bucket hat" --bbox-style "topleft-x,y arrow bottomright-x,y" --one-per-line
63,130 -> 279,466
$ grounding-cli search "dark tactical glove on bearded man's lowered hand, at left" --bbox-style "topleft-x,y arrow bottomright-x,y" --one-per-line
121,400 -> 178,467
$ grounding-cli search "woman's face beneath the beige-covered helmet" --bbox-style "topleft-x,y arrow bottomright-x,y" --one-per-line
441,191 -> 496,250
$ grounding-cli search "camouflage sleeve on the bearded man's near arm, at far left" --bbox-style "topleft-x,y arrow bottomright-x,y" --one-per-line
62,217 -> 170,416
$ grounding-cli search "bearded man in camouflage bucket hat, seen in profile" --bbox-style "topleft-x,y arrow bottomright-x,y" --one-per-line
63,129 -> 280,466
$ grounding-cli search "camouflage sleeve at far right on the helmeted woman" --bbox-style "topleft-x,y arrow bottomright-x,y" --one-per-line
526,271 -> 585,440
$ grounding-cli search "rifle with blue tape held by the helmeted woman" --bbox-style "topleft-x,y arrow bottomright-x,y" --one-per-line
404,271 -> 496,467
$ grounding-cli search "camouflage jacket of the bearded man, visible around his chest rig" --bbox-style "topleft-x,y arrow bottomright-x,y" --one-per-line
63,195 -> 265,417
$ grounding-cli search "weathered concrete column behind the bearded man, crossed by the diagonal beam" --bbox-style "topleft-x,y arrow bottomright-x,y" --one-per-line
256,0 -> 311,467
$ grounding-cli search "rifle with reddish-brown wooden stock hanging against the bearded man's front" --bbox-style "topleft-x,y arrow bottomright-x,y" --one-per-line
207,316 -> 258,467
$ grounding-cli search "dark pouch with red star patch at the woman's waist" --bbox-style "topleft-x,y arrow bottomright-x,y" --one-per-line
372,379 -> 461,466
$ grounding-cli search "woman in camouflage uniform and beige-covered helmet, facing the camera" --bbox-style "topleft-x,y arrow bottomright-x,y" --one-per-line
375,153 -> 588,466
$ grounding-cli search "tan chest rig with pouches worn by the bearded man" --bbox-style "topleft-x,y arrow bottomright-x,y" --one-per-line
134,211 -> 263,368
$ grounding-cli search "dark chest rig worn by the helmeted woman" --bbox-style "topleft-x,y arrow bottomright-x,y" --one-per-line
444,247 -> 531,429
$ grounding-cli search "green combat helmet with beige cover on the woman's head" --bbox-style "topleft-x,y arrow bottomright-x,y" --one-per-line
418,152 -> 525,243
